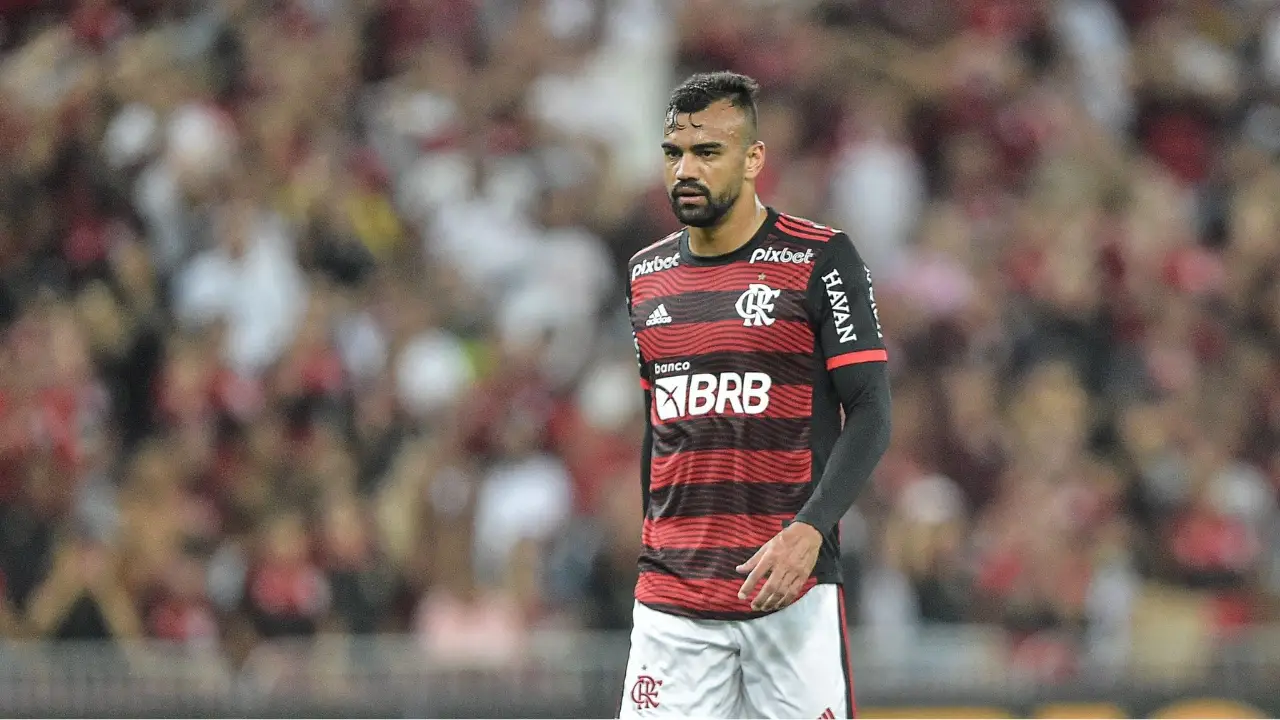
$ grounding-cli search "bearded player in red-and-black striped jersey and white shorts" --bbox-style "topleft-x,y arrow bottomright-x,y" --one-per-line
622,73 -> 890,717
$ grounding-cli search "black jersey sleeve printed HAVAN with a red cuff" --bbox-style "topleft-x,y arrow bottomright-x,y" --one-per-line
808,233 -> 888,370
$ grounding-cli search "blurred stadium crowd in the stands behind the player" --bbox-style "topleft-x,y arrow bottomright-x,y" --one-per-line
0,0 -> 1280,716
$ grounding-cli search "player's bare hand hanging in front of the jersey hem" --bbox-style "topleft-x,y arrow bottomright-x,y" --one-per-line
737,523 -> 822,611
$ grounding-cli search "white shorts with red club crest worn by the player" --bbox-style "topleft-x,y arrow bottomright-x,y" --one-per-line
618,584 -> 854,719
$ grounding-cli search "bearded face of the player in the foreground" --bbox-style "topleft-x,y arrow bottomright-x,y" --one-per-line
662,100 -> 764,228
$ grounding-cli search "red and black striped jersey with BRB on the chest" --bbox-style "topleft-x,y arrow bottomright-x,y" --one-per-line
627,209 -> 886,619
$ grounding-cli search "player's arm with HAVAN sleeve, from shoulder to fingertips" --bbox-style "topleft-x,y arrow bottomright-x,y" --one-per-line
739,233 -> 891,610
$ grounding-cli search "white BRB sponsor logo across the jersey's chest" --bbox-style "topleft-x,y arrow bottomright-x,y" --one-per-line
653,365 -> 773,420
